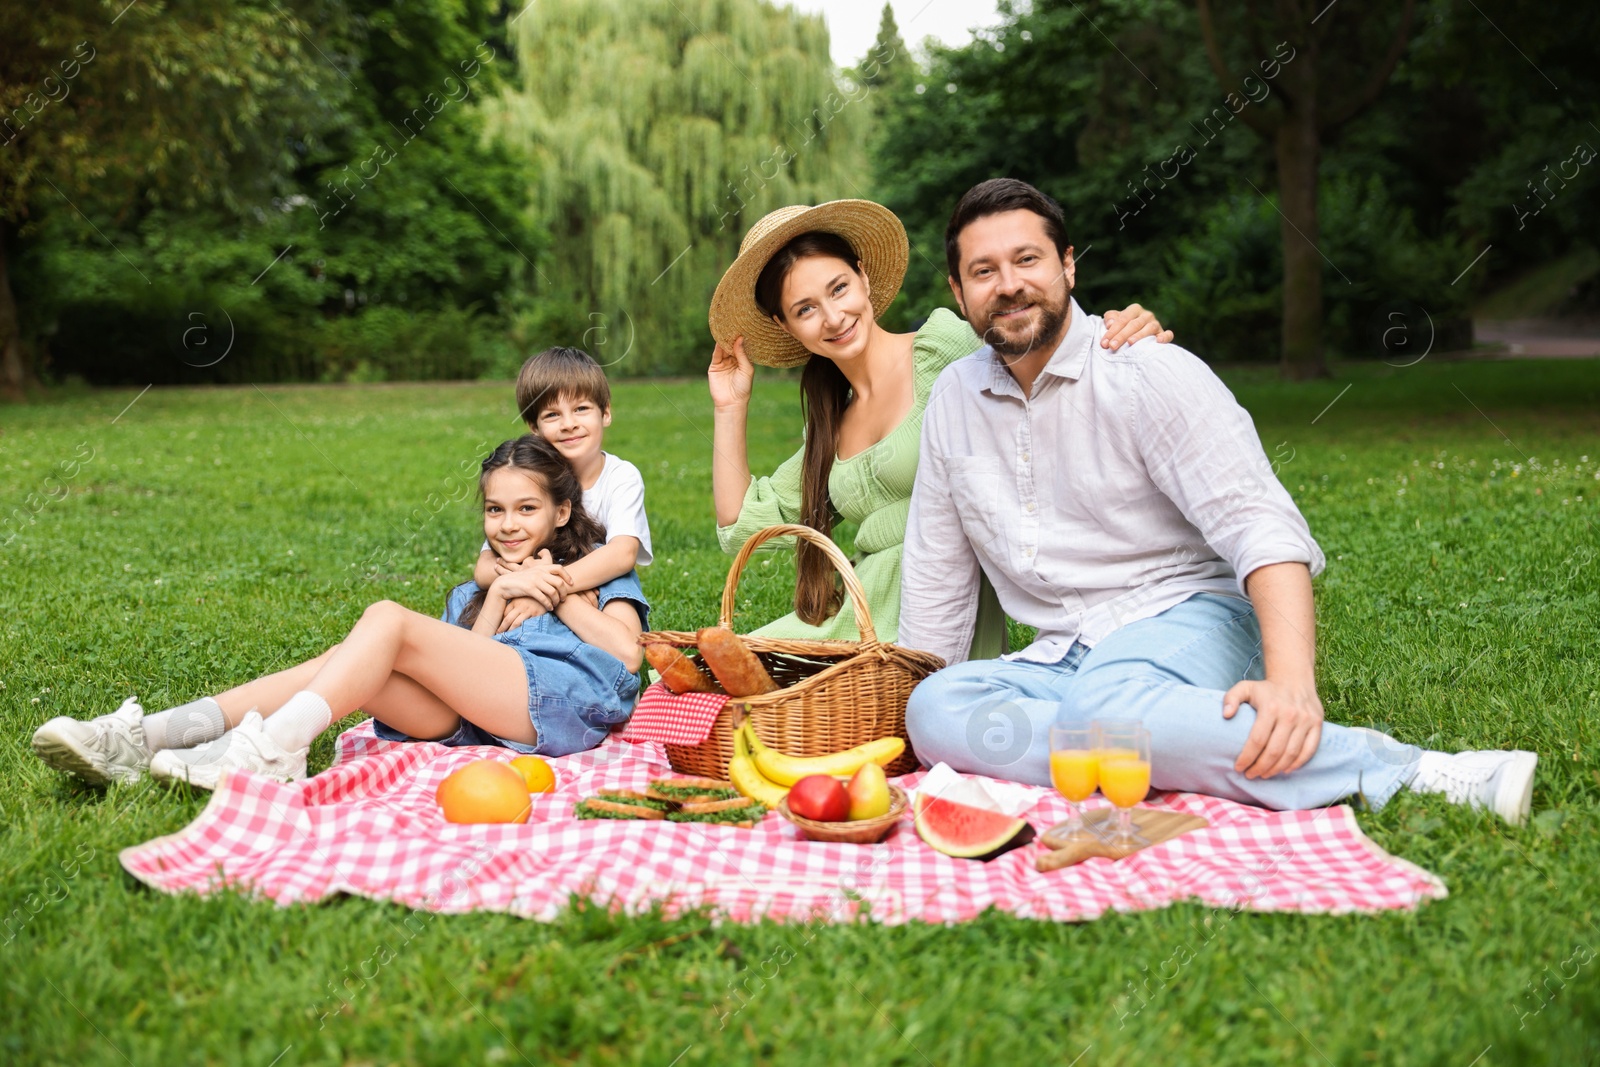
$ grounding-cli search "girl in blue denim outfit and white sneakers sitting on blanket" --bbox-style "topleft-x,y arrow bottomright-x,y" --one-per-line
34,434 -> 650,789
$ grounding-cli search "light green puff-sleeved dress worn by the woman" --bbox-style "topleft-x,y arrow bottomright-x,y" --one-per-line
717,307 -> 1005,659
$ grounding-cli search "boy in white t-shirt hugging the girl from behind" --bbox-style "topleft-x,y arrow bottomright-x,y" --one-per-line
472,347 -> 653,632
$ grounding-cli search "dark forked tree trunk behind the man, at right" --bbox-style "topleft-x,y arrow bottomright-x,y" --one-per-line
1195,0 -> 1416,381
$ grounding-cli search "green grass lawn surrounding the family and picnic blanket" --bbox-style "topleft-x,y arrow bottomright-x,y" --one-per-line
0,362 -> 1600,1067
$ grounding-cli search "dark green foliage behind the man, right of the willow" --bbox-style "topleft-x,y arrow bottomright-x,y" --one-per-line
874,0 -> 1600,360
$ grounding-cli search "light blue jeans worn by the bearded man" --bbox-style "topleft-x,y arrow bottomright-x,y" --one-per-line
906,593 -> 1421,811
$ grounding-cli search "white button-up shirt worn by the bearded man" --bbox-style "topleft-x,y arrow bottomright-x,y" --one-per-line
899,301 -> 1323,664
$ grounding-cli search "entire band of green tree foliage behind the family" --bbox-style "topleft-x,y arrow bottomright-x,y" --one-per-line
0,0 -> 1600,394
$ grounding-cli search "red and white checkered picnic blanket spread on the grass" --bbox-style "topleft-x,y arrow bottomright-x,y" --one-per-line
122,723 -> 1445,923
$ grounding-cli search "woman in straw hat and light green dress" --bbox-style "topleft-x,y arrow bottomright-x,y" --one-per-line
707,200 -> 1173,657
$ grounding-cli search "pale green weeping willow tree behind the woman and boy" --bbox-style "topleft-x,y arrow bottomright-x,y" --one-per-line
486,0 -> 869,374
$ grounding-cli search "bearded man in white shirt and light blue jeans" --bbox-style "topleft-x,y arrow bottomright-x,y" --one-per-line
899,178 -> 1538,824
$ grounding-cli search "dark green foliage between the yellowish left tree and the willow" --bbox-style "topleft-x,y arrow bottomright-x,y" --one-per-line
7,0 -> 539,384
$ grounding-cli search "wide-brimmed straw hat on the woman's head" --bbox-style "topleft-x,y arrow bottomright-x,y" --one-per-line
710,200 -> 910,366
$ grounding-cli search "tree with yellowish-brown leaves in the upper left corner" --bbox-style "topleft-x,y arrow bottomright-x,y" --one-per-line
0,0 -> 342,398
